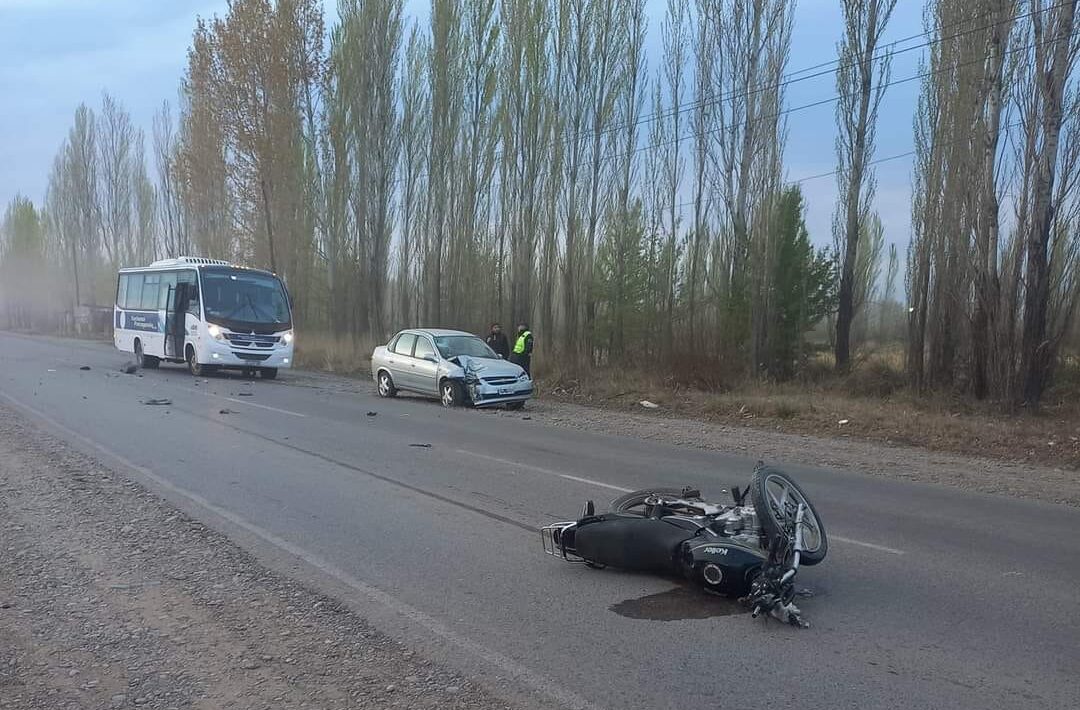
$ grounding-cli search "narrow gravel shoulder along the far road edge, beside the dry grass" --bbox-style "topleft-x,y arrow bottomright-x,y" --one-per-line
285,371 -> 1080,507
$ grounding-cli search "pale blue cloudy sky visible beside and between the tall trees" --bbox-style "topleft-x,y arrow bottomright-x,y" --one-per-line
0,0 -> 924,252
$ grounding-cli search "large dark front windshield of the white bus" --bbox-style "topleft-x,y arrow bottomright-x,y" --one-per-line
202,269 -> 291,325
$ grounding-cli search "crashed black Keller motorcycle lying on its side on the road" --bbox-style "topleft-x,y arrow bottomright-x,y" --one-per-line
540,464 -> 828,627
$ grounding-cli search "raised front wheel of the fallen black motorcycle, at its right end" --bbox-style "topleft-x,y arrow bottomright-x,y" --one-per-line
750,466 -> 828,566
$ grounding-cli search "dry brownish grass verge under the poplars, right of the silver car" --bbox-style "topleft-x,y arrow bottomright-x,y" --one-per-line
539,353 -> 1080,470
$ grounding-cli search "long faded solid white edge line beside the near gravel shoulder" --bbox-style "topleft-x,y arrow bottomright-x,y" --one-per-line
0,392 -> 598,710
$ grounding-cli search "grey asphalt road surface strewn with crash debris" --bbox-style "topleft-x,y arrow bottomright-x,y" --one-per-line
0,334 -> 1080,709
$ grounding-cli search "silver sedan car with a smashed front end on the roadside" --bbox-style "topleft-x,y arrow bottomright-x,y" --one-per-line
372,329 -> 532,410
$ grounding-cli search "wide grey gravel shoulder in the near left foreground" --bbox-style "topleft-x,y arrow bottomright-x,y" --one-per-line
0,406 -> 508,710
